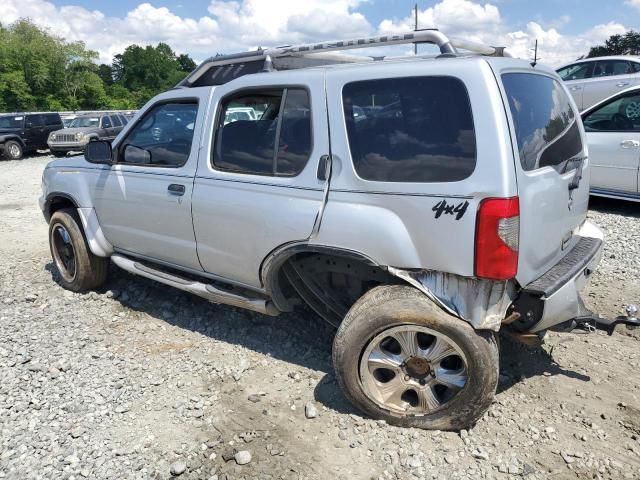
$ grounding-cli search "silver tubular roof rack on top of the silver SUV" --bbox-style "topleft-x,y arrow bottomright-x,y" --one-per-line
176,29 -> 511,88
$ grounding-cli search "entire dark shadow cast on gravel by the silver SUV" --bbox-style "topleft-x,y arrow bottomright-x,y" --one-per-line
45,263 -> 589,415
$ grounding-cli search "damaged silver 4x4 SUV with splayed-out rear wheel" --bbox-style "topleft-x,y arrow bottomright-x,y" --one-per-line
40,31 -> 616,429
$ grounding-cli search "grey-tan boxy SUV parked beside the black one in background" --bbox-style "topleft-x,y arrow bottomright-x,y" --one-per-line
47,113 -> 128,157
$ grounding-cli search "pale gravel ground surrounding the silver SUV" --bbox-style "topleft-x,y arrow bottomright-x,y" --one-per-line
0,156 -> 640,480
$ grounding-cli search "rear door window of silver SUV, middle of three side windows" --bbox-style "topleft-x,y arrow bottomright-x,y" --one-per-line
213,88 -> 312,176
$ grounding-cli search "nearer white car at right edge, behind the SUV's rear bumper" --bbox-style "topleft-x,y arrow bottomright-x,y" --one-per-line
581,85 -> 640,201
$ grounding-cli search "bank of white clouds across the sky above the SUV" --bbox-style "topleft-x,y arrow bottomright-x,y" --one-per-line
2,0 -> 640,65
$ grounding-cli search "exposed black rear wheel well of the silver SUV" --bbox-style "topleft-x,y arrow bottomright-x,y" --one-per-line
266,248 -> 399,327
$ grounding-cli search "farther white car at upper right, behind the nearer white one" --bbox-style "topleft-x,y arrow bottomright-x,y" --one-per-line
557,55 -> 640,110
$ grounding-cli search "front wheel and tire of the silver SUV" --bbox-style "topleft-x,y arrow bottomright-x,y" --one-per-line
49,208 -> 109,292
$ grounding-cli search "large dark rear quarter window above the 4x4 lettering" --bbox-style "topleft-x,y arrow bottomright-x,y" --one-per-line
342,77 -> 476,182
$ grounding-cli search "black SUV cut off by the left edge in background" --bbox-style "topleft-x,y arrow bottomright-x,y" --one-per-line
0,113 -> 63,160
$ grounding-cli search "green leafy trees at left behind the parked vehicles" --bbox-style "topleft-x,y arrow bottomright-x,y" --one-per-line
0,20 -> 196,111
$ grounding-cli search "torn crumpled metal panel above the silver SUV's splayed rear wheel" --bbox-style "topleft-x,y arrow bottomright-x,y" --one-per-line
388,267 -> 515,331
